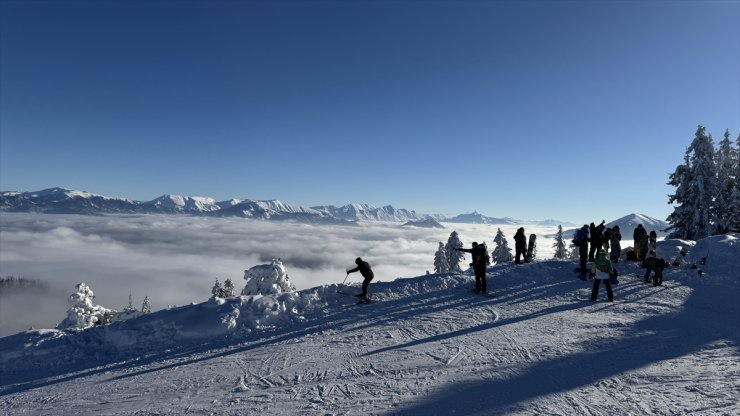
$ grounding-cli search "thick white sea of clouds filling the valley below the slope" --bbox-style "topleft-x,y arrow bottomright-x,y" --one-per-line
0,213 -> 554,336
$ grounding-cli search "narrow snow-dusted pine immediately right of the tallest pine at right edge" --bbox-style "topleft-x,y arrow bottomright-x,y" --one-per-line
714,129 -> 737,234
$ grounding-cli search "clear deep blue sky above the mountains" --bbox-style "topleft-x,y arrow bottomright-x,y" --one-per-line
0,0 -> 740,222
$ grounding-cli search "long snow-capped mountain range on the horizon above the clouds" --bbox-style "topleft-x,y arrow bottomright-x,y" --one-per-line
0,188 -> 575,227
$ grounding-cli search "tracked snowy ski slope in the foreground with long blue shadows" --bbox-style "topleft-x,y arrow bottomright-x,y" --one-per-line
0,234 -> 740,415
